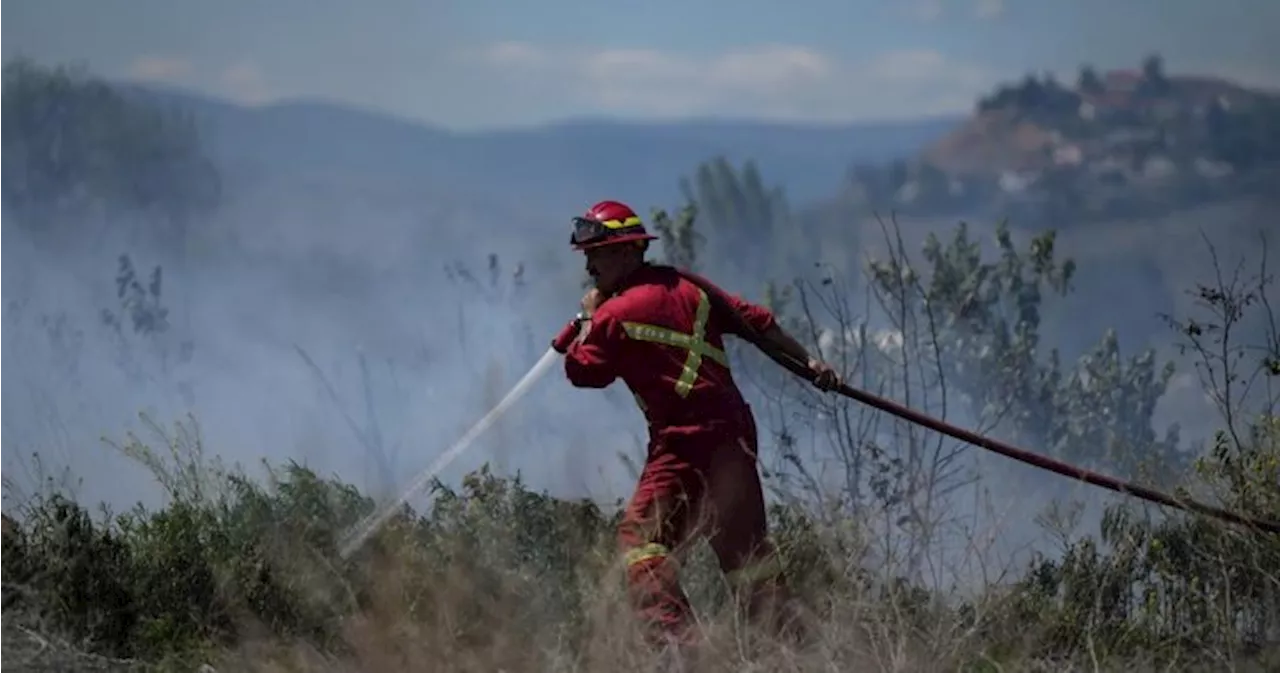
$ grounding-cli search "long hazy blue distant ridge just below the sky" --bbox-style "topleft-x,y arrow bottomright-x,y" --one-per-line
132,86 -> 963,207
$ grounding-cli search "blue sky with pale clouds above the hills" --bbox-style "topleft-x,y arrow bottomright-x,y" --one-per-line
0,0 -> 1280,129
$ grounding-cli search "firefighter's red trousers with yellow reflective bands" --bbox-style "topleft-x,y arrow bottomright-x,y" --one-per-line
618,420 -> 788,640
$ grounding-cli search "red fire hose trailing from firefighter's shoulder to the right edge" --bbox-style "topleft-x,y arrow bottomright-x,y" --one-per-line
680,270 -> 1280,534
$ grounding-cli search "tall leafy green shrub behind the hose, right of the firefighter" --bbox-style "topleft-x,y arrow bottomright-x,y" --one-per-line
870,223 -> 1187,481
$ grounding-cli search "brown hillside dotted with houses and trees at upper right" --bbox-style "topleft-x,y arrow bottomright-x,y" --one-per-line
834,56 -> 1280,226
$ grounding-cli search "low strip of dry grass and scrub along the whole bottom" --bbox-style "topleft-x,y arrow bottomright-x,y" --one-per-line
0,406 -> 1280,673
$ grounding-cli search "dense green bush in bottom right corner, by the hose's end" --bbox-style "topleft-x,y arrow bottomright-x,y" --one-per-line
998,420 -> 1280,655
